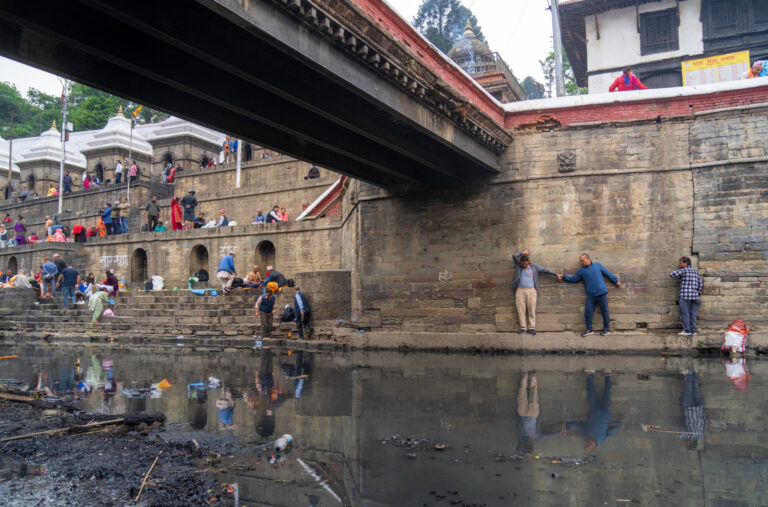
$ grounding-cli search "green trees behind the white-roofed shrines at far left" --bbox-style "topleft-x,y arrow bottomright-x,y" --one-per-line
0,83 -> 168,138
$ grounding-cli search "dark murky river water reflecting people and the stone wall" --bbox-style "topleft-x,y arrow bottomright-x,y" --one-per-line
0,344 -> 768,506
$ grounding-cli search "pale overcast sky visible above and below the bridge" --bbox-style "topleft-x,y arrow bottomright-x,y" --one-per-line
0,0 -> 552,96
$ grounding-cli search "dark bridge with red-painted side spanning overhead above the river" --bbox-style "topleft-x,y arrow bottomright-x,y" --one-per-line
0,0 -> 510,186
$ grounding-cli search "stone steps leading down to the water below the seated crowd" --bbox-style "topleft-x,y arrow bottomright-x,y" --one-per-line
0,290 -> 293,340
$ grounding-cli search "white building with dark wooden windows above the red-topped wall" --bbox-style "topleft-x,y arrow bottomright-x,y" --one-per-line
560,0 -> 768,93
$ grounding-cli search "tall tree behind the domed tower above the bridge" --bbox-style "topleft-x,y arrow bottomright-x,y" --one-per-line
413,0 -> 485,54
